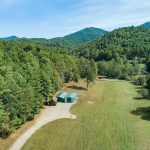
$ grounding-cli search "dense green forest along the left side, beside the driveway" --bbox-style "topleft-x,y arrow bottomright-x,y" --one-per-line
0,40 -> 96,136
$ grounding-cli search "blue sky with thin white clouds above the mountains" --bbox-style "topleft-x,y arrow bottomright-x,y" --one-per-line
0,0 -> 150,39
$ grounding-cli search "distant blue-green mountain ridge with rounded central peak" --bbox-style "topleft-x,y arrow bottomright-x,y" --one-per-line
17,28 -> 107,50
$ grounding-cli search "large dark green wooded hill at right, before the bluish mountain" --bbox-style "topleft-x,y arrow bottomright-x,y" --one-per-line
73,26 -> 150,61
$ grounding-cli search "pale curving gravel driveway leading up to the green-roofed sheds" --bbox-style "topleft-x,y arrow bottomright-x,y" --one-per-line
10,103 -> 77,150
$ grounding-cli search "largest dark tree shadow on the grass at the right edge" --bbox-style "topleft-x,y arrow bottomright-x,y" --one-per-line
130,107 -> 150,121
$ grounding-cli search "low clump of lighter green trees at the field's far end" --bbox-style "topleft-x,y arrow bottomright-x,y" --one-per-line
97,55 -> 140,80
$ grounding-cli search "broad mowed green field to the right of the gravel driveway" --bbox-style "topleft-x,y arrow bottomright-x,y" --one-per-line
22,81 -> 150,150
